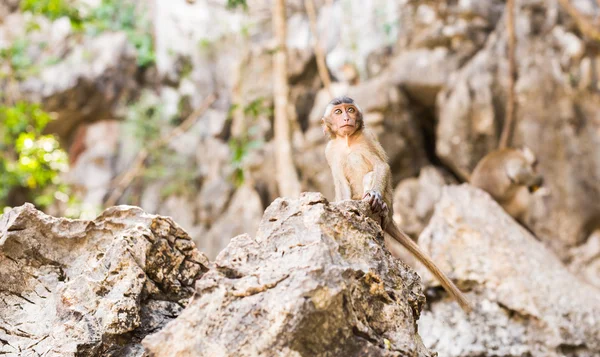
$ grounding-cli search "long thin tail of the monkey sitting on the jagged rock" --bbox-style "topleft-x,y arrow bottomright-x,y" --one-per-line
385,222 -> 473,313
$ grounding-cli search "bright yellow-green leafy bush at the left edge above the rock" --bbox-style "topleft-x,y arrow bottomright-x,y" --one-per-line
0,102 -> 68,208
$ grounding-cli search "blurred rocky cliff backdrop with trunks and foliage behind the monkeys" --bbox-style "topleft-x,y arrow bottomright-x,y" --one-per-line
0,0 -> 600,286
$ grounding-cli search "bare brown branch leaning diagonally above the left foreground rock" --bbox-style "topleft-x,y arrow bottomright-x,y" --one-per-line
104,94 -> 217,207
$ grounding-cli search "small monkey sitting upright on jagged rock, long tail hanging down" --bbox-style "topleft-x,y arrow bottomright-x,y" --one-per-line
321,96 -> 472,312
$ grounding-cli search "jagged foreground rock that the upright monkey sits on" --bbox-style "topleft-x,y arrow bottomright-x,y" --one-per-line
143,193 -> 436,357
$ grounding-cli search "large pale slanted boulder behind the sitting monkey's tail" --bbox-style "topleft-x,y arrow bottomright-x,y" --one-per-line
419,184 -> 600,357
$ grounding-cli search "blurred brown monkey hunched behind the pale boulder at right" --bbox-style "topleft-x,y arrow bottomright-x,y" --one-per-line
469,147 -> 542,223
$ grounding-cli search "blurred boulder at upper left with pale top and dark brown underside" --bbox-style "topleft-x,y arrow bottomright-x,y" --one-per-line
22,32 -> 138,141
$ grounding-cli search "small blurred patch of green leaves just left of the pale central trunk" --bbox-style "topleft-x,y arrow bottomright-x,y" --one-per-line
229,98 -> 273,187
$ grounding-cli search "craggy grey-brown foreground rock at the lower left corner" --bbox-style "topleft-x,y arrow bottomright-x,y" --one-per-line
0,204 -> 208,357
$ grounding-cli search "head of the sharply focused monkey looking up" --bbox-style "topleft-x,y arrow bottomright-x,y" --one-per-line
321,96 -> 364,139
